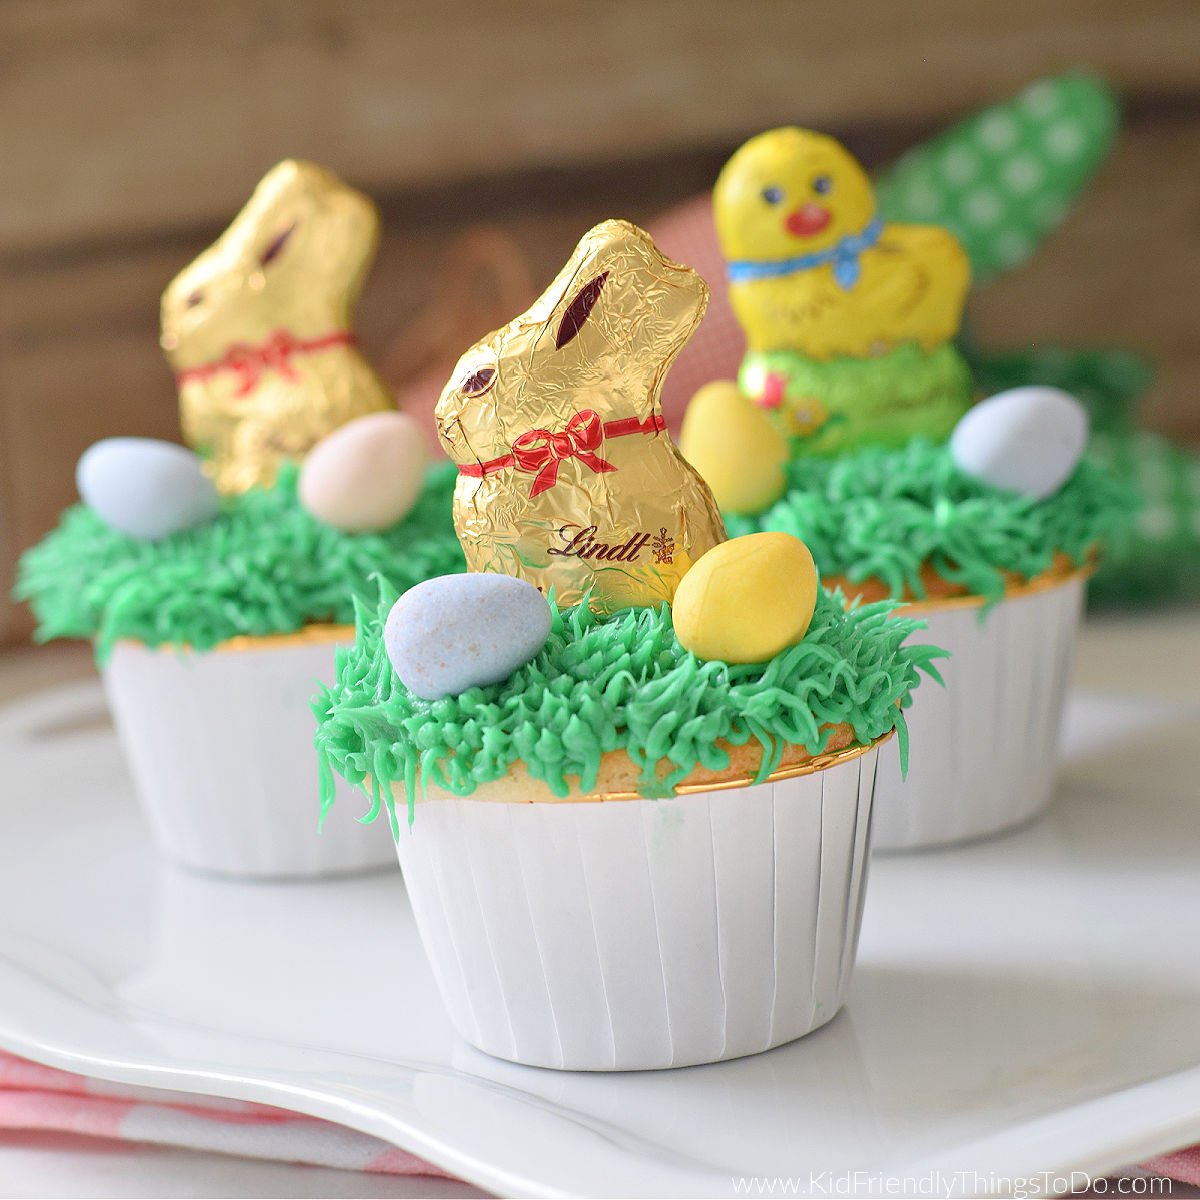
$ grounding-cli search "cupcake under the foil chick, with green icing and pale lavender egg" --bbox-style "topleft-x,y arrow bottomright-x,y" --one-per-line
726,388 -> 1136,850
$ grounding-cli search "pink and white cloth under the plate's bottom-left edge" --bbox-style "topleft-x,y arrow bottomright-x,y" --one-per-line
0,1051 -> 448,1178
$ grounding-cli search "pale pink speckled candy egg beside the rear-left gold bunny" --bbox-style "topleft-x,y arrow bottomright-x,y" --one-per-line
299,413 -> 428,533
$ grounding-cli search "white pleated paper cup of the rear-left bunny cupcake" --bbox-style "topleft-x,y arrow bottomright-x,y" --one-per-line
102,625 -> 394,878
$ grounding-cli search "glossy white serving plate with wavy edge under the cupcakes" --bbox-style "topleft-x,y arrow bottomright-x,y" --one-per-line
0,684 -> 1200,1196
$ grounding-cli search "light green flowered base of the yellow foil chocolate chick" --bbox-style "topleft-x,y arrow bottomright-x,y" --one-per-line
738,342 -> 972,455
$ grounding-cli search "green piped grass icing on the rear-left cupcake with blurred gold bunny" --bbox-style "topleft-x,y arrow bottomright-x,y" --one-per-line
14,463 -> 466,662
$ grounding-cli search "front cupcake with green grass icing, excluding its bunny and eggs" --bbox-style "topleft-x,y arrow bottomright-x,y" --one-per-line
316,571 -> 930,1070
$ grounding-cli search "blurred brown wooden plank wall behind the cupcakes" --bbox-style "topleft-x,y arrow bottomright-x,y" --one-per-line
0,0 -> 1200,641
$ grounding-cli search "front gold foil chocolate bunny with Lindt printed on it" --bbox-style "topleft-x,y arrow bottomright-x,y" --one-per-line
437,221 -> 725,612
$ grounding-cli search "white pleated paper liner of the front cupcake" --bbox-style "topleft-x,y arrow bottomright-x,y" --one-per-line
397,744 -> 878,1070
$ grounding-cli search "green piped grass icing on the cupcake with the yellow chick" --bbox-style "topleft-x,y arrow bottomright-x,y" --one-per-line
726,439 -> 1138,600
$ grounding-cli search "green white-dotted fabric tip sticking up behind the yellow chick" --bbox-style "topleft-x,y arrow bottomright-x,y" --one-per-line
876,72 -> 1118,282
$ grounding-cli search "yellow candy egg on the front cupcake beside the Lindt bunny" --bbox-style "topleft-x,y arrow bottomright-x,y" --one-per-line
671,533 -> 817,662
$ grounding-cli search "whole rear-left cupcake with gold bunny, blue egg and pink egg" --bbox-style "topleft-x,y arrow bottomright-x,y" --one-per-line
17,162 -> 464,876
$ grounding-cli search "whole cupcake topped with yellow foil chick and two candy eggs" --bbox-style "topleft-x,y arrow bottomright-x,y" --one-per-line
683,124 -> 1133,848
